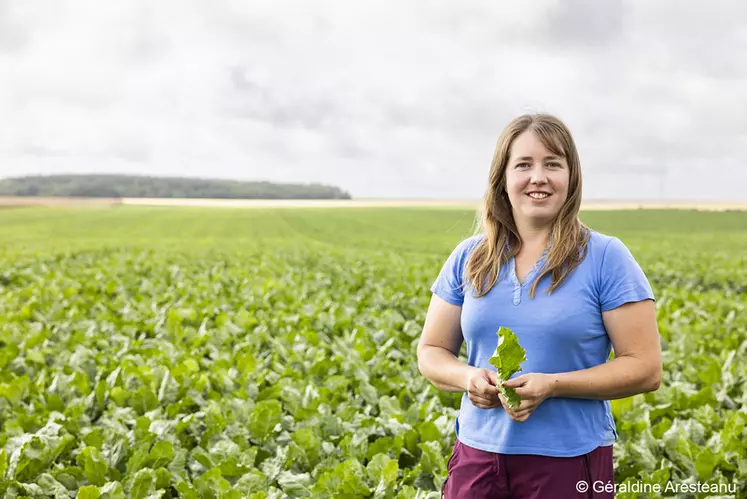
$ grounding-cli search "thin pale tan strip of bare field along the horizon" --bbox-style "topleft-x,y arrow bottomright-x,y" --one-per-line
0,196 -> 747,211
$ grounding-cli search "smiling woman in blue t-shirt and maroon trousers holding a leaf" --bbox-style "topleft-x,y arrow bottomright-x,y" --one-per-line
417,115 -> 661,499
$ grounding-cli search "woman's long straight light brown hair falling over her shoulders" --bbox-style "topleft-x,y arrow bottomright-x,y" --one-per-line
465,114 -> 589,298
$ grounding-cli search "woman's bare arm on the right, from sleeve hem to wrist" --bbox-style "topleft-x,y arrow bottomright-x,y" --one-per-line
548,300 -> 662,400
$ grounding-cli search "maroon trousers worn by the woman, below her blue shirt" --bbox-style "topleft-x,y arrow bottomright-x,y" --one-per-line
441,439 -> 614,499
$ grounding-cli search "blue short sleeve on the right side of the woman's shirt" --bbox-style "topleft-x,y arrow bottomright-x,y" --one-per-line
599,237 -> 655,312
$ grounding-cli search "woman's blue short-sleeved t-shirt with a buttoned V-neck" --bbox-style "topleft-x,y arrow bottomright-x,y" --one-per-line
431,230 -> 654,457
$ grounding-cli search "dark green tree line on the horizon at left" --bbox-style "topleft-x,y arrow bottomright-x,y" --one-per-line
0,175 -> 351,199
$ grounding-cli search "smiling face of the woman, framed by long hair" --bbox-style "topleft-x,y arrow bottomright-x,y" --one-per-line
506,130 -> 570,225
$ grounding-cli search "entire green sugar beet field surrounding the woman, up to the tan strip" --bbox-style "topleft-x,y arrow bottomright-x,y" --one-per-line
0,206 -> 747,499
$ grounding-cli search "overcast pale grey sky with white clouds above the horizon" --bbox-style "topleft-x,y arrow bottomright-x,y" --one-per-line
0,0 -> 747,200
